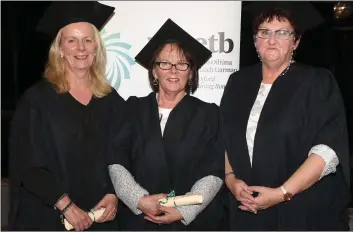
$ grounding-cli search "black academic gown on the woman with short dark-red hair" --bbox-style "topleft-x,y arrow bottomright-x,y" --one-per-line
221,63 -> 350,230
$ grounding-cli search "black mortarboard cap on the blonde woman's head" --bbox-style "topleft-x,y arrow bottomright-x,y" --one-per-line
37,1 -> 115,40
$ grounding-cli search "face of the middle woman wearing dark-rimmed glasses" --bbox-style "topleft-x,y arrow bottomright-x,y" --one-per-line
152,44 -> 192,93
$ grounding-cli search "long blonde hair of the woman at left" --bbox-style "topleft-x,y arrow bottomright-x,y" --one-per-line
43,24 -> 112,98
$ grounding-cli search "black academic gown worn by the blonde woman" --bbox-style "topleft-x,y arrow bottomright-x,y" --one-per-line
9,81 -> 125,230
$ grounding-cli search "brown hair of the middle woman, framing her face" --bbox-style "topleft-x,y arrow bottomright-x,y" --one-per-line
148,40 -> 199,93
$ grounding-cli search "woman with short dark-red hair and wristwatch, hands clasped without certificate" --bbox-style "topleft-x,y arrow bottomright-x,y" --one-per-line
221,2 -> 350,230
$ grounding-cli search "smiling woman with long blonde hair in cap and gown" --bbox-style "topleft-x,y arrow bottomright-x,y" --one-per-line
9,2 -> 125,230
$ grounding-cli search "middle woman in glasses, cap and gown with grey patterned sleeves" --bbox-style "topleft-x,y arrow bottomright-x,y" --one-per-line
109,19 -> 224,230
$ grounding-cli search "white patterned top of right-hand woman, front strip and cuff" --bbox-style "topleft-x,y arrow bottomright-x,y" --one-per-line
246,83 -> 339,179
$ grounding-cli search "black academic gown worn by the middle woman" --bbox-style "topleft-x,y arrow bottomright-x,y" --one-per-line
112,93 -> 224,230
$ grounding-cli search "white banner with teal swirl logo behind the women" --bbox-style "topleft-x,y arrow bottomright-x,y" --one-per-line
100,1 -> 241,104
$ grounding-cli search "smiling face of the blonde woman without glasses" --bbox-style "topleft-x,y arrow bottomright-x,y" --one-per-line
60,22 -> 97,71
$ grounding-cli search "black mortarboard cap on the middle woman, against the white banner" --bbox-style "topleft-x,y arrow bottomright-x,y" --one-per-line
135,19 -> 212,70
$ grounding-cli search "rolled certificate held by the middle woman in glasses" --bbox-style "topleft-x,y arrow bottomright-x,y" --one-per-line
158,194 -> 203,207
